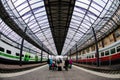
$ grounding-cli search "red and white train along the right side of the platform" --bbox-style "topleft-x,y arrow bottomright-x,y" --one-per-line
74,40 -> 120,65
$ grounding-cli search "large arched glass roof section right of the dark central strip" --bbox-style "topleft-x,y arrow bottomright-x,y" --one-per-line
62,0 -> 119,55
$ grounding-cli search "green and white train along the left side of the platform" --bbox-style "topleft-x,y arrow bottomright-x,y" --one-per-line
0,40 -> 46,63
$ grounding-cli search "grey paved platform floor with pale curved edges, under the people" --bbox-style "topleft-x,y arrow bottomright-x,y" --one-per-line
0,65 -> 120,80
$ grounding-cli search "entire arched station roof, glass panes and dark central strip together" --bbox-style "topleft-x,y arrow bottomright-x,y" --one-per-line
0,0 -> 120,55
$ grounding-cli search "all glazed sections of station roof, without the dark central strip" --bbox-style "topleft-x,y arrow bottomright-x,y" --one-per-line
0,0 -> 119,54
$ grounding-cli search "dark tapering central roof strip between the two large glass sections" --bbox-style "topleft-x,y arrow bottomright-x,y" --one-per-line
44,0 -> 75,55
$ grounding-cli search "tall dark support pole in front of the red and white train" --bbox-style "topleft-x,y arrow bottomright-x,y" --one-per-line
92,27 -> 99,67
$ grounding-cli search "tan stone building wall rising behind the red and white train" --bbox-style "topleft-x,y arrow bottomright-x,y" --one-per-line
71,27 -> 120,59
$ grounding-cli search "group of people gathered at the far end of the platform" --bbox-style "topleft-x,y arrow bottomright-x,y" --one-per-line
47,58 -> 72,71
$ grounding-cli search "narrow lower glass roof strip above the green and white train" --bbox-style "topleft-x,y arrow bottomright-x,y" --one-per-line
0,19 -> 41,53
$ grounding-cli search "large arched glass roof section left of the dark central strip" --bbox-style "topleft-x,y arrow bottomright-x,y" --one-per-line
2,0 -> 57,54
